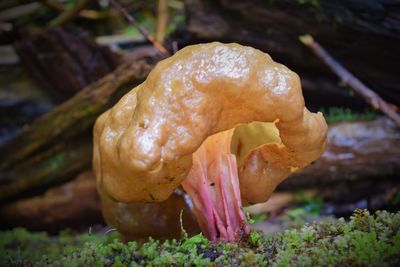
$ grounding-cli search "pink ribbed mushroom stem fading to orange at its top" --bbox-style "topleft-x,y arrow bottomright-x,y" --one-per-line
182,130 -> 249,242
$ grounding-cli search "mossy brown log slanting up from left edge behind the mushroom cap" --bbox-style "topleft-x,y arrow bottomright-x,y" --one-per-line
0,61 -> 152,201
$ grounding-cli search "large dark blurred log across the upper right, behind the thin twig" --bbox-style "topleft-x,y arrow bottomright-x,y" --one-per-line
185,0 -> 400,105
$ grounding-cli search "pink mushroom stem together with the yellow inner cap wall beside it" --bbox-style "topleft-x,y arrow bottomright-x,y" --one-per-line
182,122 -> 280,242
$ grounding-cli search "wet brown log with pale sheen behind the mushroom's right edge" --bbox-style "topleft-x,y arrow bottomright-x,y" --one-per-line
279,118 -> 400,189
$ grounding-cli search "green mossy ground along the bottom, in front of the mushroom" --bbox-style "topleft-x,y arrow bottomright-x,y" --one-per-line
0,210 -> 400,266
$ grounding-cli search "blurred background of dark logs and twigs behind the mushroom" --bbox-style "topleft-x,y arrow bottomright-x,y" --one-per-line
0,0 -> 400,238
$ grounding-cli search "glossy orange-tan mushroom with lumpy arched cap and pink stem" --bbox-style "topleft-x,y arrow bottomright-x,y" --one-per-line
93,42 -> 327,242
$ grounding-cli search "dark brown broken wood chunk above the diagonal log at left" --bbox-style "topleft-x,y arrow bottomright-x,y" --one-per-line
14,28 -> 119,102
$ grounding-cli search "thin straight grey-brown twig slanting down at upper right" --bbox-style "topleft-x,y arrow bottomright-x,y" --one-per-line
299,35 -> 400,127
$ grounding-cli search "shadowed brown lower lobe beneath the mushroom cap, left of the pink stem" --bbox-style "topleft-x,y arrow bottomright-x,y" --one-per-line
100,190 -> 199,241
